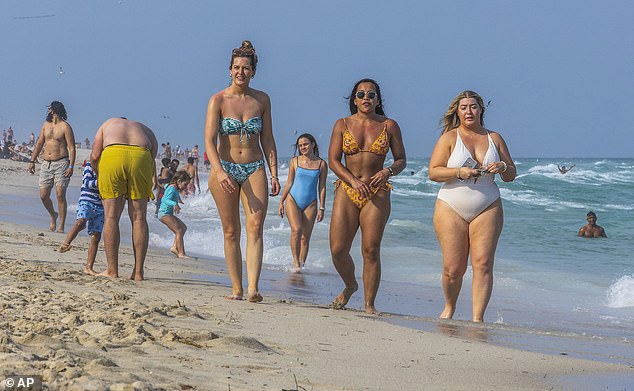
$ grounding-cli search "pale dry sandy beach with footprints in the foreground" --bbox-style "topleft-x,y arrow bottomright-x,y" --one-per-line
0,155 -> 634,390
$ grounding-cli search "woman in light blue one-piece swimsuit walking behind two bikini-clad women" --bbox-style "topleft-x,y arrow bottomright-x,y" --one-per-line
278,133 -> 328,273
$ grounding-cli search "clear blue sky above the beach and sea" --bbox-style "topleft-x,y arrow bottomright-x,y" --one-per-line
0,0 -> 634,158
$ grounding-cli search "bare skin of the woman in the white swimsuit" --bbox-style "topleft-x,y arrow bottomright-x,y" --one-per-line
429,98 -> 515,322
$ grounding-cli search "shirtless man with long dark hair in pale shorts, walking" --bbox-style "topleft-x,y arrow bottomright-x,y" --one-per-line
28,101 -> 76,232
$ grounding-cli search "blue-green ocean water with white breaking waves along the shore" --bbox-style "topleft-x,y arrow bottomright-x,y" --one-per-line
0,158 -> 634,363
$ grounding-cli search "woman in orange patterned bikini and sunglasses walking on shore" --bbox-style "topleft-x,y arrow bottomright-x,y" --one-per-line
328,79 -> 407,313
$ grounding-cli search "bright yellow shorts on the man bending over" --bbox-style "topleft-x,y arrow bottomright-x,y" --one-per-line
97,144 -> 154,200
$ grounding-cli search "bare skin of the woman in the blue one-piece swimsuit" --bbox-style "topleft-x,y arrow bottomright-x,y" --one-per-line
278,137 -> 328,273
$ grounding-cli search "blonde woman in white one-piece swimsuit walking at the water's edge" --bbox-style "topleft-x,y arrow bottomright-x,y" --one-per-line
429,91 -> 516,322
